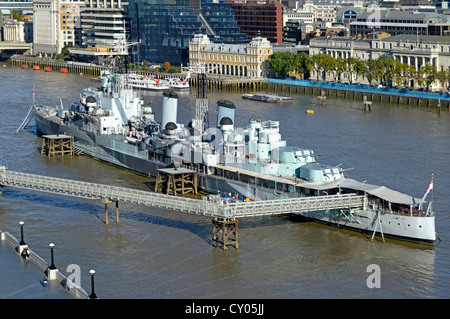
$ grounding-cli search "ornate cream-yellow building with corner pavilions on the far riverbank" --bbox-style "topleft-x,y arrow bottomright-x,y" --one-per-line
189,34 -> 273,77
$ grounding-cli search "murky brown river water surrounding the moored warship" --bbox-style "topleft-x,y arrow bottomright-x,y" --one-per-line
0,65 -> 450,299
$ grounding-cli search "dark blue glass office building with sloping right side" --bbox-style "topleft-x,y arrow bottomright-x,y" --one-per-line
128,0 -> 248,65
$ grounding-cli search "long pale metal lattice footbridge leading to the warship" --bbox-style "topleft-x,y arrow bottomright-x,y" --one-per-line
0,170 -> 367,219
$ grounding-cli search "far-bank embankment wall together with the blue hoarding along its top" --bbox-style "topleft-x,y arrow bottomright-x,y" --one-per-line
10,55 -> 450,111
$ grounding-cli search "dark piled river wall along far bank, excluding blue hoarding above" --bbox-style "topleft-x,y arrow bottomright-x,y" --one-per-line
10,55 -> 450,112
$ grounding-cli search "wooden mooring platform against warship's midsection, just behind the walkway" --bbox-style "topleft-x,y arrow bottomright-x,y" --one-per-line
155,167 -> 197,196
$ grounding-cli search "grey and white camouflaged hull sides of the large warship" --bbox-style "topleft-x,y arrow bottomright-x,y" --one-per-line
35,113 -> 436,244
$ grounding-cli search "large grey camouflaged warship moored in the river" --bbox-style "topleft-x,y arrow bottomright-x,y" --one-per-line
28,36 -> 437,244
